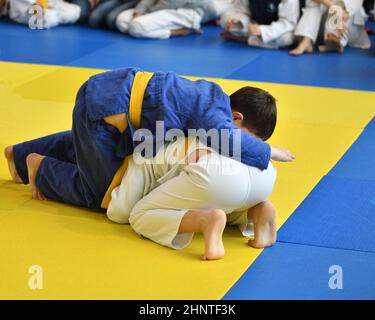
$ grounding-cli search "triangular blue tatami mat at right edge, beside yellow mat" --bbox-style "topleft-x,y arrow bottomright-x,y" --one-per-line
278,119 -> 375,252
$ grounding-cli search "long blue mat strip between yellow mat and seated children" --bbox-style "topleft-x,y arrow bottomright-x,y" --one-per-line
0,20 -> 375,91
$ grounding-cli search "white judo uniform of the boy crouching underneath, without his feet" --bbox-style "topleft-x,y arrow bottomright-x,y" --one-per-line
107,139 -> 276,249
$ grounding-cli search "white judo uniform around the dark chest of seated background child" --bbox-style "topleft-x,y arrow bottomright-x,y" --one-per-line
220,0 -> 300,49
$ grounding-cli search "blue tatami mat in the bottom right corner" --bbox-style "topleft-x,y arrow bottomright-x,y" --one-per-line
224,243 -> 375,300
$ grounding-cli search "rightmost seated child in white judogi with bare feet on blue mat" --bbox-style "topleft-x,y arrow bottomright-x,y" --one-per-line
290,0 -> 371,55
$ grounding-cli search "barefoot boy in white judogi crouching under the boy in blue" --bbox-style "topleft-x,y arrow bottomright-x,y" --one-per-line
107,138 -> 276,259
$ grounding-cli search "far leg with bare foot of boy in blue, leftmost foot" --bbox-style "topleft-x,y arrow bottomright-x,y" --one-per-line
5,131 -> 76,184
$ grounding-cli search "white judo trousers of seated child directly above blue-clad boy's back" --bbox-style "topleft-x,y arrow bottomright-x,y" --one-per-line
116,8 -> 206,39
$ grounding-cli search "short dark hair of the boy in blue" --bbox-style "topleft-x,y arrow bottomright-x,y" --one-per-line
230,87 -> 277,141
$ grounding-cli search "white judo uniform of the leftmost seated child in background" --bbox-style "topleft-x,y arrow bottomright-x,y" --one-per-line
9,0 -> 81,28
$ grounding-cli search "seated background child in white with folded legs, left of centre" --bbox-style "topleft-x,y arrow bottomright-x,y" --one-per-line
116,0 -> 206,39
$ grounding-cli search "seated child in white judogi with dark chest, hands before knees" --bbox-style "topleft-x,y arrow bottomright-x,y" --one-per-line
221,0 -> 300,49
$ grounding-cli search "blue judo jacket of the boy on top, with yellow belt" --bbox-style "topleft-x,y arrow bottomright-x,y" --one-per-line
83,68 -> 270,169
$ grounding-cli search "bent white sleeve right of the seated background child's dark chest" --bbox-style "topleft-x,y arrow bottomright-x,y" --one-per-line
259,0 -> 299,43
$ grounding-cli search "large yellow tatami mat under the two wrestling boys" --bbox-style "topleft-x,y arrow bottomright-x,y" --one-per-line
0,62 -> 375,299
